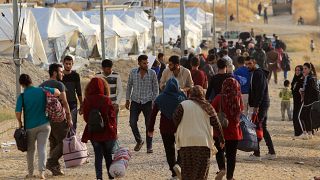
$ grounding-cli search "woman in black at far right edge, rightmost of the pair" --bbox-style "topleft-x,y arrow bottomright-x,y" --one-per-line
299,63 -> 319,140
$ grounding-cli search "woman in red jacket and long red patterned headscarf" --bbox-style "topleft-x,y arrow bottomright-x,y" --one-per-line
212,78 -> 243,180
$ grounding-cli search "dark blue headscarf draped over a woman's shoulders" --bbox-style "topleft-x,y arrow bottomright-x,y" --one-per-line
155,77 -> 187,119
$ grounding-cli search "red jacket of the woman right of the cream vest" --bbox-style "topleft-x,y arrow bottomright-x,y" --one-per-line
211,95 -> 242,140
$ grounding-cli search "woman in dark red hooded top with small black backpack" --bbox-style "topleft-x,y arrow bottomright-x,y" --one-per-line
82,78 -> 117,180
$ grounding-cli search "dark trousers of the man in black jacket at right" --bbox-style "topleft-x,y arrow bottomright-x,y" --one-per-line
253,107 -> 276,156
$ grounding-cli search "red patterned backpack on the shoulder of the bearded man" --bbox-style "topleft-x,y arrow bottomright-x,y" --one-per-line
43,89 -> 66,122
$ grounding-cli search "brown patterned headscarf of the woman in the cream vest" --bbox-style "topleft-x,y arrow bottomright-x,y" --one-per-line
189,85 -> 216,117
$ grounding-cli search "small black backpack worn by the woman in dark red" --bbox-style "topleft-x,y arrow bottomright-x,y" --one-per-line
88,99 -> 106,133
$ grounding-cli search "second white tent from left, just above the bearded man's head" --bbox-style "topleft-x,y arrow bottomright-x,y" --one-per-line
31,8 -> 79,63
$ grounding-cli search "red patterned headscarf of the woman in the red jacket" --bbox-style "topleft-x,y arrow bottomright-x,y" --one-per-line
221,77 -> 243,117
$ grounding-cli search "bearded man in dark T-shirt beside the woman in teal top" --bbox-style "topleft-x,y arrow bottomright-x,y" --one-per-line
40,63 -> 72,176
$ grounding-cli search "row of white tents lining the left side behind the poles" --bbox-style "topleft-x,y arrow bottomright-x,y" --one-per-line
0,6 -> 212,64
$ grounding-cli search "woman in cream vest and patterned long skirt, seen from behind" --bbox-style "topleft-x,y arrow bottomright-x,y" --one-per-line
173,85 -> 224,180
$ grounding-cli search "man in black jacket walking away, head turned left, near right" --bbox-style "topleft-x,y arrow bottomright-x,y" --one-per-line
245,58 -> 276,161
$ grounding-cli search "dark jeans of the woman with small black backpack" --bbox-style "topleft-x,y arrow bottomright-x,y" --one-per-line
91,140 -> 115,179
